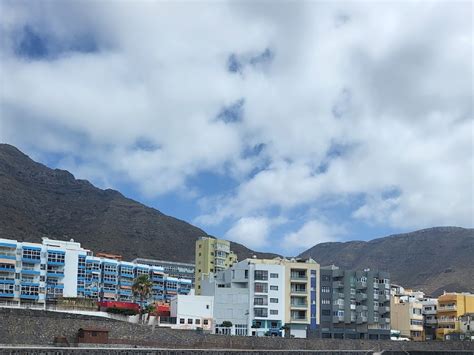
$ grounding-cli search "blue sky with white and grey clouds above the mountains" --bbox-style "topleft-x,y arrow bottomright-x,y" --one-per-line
0,0 -> 474,255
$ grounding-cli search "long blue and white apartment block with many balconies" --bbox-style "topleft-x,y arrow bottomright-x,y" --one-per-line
0,238 -> 192,304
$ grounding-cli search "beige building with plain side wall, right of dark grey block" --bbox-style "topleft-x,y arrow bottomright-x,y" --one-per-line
390,292 -> 425,341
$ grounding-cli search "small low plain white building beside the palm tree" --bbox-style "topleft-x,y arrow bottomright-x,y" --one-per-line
170,295 -> 214,331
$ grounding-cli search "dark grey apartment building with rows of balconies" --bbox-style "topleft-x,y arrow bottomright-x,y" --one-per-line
319,266 -> 390,339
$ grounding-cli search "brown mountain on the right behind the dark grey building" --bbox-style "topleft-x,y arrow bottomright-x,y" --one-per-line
300,227 -> 474,296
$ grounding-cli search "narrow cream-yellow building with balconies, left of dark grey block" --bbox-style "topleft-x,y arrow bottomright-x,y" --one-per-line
284,259 -> 320,337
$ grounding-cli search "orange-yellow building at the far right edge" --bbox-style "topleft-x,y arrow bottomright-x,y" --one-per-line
436,292 -> 474,340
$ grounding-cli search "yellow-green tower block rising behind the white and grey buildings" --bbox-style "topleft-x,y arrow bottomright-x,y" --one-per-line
194,237 -> 237,295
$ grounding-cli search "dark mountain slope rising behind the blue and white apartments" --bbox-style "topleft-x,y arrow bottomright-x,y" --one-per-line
0,144 -> 275,262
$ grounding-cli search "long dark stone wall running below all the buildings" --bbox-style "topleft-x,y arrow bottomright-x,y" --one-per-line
0,308 -> 474,354
